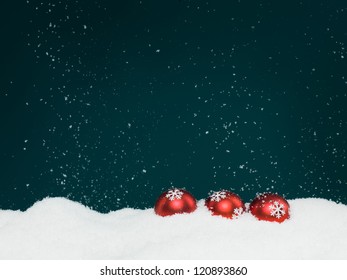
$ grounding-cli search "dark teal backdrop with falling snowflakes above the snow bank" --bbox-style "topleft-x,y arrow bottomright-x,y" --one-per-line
0,0 -> 347,212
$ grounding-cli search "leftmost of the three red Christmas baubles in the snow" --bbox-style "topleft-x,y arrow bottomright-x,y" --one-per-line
154,188 -> 196,216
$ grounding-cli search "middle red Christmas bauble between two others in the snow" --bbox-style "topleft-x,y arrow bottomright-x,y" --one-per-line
205,190 -> 246,219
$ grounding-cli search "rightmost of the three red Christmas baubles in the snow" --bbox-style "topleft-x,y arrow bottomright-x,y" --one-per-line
249,193 -> 289,223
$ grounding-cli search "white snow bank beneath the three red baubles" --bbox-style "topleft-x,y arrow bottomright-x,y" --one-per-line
0,198 -> 347,260
